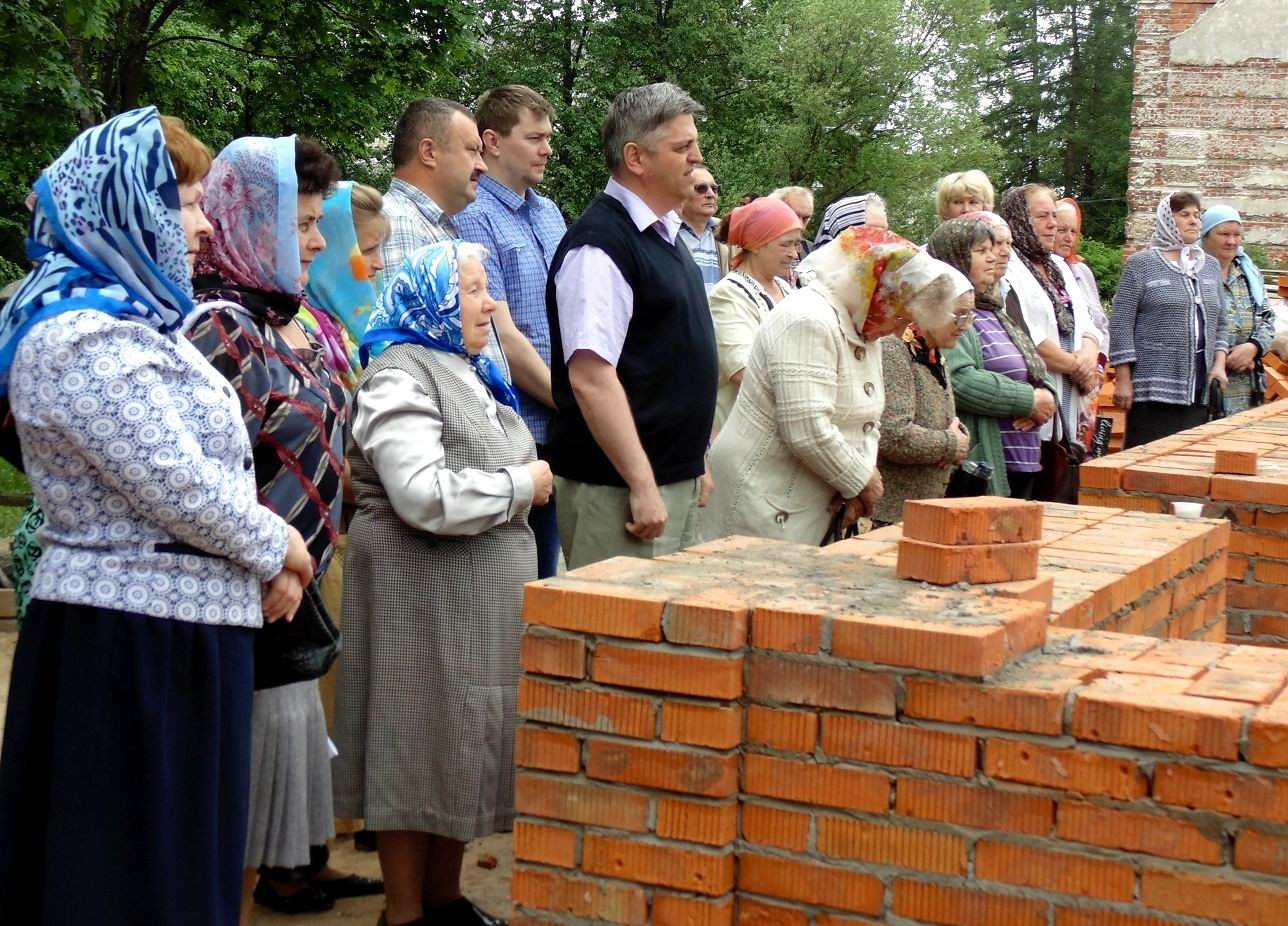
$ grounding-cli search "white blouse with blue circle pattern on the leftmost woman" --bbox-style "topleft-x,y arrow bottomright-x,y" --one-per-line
9,310 -> 286,627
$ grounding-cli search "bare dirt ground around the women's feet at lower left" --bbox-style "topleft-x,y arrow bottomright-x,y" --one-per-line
0,621 -> 514,926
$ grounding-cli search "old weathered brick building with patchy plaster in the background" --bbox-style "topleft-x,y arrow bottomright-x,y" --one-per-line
1127,0 -> 1288,265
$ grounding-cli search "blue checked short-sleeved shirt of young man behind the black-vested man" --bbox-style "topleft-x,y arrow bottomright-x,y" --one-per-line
455,174 -> 568,444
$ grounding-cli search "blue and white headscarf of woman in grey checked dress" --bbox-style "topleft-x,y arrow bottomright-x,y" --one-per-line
361,241 -> 519,411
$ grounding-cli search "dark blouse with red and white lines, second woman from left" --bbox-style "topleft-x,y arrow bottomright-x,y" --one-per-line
188,298 -> 348,576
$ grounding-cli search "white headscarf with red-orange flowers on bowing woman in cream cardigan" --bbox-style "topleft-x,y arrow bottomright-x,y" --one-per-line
797,227 -> 954,340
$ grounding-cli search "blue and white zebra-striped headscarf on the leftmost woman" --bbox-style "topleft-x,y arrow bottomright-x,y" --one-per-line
0,106 -> 193,394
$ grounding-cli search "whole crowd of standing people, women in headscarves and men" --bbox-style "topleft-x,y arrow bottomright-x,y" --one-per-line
0,77 -> 1273,926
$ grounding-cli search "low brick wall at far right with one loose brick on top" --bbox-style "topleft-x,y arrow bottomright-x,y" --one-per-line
1078,402 -> 1288,647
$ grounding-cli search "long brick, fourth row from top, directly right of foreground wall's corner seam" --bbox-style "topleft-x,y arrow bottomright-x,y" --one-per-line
742,753 -> 890,814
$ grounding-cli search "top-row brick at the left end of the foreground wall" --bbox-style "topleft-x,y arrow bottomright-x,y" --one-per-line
523,578 -> 667,640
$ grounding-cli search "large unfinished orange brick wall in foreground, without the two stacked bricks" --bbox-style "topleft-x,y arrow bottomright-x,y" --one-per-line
511,506 -> 1288,926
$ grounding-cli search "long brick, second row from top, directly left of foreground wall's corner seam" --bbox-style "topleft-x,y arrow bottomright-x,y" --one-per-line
590,643 -> 742,698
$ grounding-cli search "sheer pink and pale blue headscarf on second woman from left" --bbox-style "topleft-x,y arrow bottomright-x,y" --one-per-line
197,135 -> 303,309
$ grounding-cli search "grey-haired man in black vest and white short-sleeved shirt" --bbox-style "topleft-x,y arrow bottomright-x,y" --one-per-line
546,84 -> 717,568
